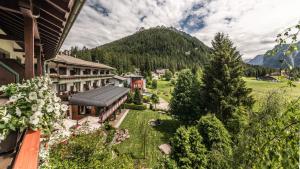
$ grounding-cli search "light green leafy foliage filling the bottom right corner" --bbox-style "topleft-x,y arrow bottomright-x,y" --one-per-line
235,91 -> 300,168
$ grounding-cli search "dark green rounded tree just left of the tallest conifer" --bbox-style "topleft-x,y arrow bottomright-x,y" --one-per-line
170,69 -> 199,122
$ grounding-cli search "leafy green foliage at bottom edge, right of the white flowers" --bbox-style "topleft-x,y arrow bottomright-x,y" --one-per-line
49,131 -> 134,169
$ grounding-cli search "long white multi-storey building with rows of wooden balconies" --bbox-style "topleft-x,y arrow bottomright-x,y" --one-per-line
45,54 -> 114,100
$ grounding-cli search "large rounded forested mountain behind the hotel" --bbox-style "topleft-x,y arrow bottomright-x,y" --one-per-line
71,26 -> 210,73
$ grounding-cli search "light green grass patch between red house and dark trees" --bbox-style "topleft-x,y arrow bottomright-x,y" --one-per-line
148,80 -> 174,102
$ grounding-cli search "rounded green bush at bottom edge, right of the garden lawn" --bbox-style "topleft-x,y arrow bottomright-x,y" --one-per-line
171,127 -> 207,169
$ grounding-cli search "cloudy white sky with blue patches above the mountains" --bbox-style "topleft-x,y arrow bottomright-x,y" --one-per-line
63,0 -> 300,59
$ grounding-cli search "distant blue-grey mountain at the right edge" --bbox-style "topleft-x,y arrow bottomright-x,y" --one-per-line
247,42 -> 300,68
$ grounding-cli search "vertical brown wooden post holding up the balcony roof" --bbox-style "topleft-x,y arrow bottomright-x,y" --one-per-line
24,16 -> 34,79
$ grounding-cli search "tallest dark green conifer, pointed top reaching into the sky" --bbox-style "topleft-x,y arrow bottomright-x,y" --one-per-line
200,33 -> 254,132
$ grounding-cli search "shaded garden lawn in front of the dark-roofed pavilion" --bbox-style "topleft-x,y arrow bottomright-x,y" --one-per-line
116,110 -> 179,167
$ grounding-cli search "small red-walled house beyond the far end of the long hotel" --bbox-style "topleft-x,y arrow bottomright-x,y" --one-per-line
124,74 -> 146,92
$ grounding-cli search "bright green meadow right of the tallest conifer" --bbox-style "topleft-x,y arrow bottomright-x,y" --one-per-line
244,78 -> 300,100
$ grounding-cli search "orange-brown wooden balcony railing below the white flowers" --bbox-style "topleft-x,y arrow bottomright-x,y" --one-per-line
13,130 -> 41,169
